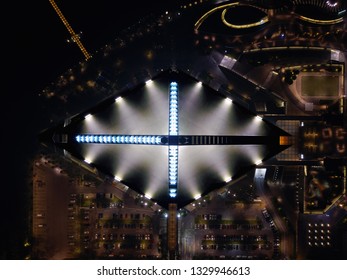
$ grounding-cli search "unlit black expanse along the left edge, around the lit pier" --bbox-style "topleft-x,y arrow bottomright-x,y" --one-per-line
0,0 -> 187,259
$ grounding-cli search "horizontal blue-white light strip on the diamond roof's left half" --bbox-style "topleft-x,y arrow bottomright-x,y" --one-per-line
75,134 -> 164,145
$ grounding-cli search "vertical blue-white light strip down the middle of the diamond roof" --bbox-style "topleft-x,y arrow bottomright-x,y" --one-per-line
169,82 -> 178,198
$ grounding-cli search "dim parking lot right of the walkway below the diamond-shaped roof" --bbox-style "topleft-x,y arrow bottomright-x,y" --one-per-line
181,187 -> 280,259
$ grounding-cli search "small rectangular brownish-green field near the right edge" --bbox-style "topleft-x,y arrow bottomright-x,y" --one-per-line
301,76 -> 339,97
